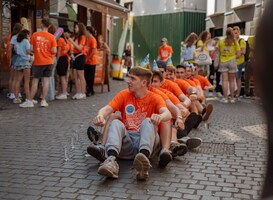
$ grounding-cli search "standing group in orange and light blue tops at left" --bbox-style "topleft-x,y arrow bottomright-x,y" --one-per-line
7,19 -> 110,108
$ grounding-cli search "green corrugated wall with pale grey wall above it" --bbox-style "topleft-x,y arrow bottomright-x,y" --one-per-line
113,0 -> 206,65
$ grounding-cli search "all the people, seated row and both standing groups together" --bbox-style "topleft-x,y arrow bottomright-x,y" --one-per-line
5,19 -> 256,180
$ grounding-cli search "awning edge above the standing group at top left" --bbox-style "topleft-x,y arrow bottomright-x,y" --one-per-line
70,0 -> 129,18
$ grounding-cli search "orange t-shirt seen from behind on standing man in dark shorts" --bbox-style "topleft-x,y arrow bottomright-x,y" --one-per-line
30,32 -> 57,66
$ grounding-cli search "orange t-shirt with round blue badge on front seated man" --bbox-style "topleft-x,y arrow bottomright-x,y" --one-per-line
108,89 -> 167,131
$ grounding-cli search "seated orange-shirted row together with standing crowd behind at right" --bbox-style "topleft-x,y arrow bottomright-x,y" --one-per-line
84,27 -> 256,180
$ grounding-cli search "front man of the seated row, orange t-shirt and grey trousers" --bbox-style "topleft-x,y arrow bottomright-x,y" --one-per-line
88,67 -> 171,180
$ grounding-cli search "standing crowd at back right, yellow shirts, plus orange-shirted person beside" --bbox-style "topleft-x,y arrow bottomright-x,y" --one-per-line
158,26 -> 254,103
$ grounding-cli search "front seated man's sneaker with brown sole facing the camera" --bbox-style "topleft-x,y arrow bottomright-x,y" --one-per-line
133,153 -> 152,180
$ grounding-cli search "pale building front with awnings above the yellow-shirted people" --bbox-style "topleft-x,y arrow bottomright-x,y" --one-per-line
206,0 -> 265,37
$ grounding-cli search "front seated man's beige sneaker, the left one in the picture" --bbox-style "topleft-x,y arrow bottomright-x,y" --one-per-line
98,156 -> 119,178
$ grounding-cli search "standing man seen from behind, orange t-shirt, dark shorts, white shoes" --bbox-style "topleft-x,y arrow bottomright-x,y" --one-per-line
20,19 -> 57,108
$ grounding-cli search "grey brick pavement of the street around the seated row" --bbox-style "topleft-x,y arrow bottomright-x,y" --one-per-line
0,81 -> 266,200
